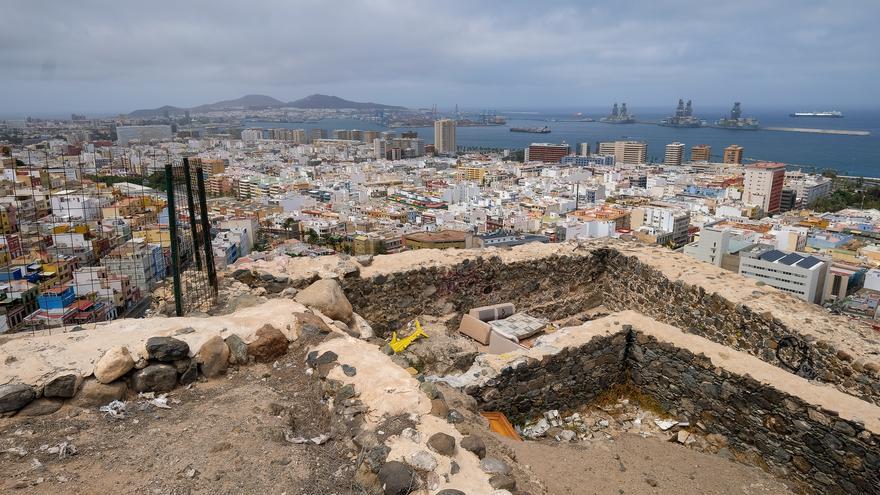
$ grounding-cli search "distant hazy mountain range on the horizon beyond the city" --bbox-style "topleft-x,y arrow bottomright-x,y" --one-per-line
128,94 -> 404,118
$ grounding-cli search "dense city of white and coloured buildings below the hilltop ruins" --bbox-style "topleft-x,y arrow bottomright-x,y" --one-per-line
0,97 -> 880,331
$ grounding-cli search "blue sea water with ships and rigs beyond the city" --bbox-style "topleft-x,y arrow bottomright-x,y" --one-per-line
243,108 -> 880,177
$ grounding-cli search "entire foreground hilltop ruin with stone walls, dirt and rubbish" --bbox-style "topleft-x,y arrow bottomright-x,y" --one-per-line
0,240 -> 880,495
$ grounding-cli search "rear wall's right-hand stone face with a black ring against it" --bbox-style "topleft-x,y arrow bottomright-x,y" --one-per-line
602,252 -> 880,404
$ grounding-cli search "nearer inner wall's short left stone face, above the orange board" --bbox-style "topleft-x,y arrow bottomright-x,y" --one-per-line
468,333 -> 626,424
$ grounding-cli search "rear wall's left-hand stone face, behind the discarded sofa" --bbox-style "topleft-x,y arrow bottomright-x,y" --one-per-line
341,252 -> 607,336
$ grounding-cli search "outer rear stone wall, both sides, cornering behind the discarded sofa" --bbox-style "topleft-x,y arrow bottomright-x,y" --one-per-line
239,243 -> 880,404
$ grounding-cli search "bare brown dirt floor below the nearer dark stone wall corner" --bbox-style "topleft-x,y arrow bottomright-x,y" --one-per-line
505,434 -> 792,495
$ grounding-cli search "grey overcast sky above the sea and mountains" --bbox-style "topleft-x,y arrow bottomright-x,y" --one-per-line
0,0 -> 880,115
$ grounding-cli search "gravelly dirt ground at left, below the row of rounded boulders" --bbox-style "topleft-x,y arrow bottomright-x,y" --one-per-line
0,339 -> 359,495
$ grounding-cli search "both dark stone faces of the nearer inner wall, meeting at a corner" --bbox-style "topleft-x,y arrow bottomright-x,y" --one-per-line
467,327 -> 880,493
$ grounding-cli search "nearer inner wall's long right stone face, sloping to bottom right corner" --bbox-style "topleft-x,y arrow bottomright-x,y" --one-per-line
628,332 -> 880,493
